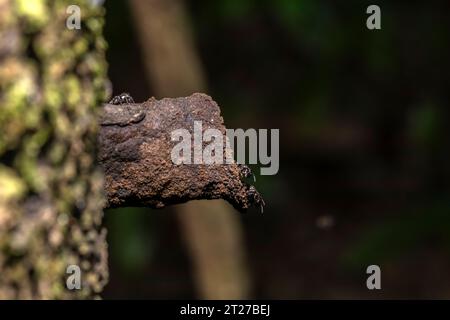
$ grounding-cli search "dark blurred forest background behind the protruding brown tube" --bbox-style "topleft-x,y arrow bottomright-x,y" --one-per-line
104,0 -> 450,299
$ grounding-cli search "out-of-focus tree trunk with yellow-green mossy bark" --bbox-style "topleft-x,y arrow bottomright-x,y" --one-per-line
0,0 -> 108,299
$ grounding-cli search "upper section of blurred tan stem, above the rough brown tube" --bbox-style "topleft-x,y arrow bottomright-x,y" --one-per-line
130,0 -> 206,97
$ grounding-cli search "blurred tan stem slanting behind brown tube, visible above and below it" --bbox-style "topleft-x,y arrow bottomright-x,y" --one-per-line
130,0 -> 250,299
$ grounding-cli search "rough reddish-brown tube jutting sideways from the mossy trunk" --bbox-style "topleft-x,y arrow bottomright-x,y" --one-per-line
98,93 -> 257,211
